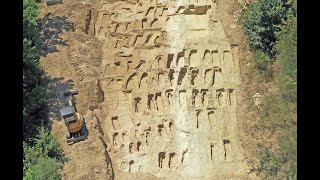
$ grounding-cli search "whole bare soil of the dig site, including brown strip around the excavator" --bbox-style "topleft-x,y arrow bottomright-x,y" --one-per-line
40,0 -> 256,180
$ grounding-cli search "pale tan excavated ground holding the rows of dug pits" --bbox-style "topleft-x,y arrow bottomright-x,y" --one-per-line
94,0 -> 247,179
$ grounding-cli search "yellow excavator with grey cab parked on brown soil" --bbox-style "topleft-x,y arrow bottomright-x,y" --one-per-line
60,90 -> 88,144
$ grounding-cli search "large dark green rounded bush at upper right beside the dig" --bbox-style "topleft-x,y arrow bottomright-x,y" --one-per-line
242,0 -> 287,56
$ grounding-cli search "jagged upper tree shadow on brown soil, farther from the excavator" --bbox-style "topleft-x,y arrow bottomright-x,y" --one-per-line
38,13 -> 74,57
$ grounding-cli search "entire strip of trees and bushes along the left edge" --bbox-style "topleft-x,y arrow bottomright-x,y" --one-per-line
23,0 -> 63,180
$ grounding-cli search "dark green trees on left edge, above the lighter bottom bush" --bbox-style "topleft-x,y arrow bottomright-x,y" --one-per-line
23,0 -> 50,141
